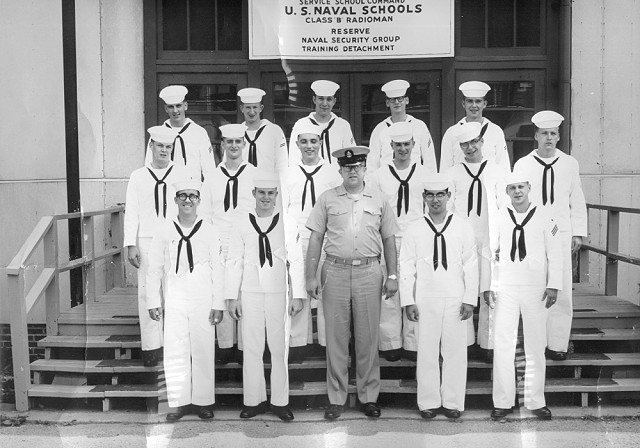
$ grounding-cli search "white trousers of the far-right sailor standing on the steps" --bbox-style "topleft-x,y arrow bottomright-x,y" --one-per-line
547,231 -> 573,352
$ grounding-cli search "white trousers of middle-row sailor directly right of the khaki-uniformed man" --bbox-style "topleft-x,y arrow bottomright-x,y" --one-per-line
379,236 -> 418,351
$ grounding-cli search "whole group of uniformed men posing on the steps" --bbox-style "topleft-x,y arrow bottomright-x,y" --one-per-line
124,80 -> 587,421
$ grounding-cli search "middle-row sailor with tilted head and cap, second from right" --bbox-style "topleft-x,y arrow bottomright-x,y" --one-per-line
445,121 -> 509,362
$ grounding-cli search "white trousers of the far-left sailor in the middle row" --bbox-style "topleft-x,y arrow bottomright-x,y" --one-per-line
137,238 -> 163,351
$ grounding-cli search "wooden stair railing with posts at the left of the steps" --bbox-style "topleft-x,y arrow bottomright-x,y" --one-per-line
3,206 -> 124,411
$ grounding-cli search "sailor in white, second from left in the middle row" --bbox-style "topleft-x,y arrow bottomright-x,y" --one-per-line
200,124 -> 257,364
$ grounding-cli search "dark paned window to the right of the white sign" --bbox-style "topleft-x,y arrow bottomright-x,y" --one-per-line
460,0 -> 543,49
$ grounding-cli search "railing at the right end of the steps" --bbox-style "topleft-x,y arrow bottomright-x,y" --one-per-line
580,204 -> 640,296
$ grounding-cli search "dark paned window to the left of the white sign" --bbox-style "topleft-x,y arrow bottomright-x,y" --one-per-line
159,0 -> 243,52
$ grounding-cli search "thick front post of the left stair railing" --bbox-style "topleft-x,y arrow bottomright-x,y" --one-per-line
2,267 -> 31,412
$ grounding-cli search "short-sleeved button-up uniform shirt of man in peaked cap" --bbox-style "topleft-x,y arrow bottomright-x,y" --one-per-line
307,185 -> 400,258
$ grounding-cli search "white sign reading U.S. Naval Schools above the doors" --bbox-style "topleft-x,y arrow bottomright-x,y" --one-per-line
249,0 -> 454,60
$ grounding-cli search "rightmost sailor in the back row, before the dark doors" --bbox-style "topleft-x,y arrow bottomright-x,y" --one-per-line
440,81 -> 511,172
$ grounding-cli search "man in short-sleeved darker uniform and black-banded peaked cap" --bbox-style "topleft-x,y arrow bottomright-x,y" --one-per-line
305,146 -> 399,420
